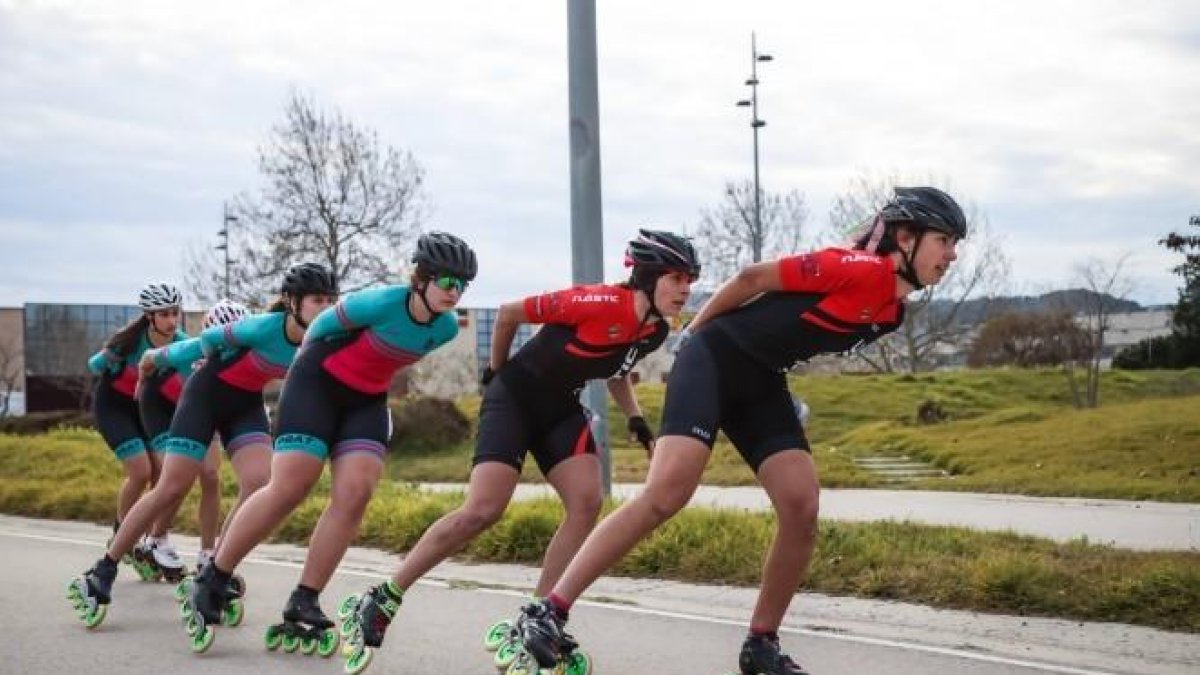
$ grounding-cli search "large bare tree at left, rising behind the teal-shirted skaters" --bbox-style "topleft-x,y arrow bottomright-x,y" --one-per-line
187,91 -> 427,305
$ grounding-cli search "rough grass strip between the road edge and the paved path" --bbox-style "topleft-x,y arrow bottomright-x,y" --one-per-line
0,431 -> 1200,633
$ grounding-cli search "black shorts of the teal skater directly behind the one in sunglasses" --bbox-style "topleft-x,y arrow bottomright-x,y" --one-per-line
167,359 -> 271,461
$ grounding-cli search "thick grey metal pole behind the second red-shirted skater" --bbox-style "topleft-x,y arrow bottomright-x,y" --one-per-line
566,0 -> 612,495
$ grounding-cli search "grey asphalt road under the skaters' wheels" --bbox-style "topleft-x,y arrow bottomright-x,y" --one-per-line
0,521 -> 1152,675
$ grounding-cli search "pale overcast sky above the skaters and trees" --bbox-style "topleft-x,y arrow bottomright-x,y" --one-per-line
0,0 -> 1200,306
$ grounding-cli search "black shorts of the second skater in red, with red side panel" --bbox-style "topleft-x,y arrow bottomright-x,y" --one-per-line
472,377 -> 596,476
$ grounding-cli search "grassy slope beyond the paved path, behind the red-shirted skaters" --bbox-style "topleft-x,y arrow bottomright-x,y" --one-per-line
389,369 -> 1200,502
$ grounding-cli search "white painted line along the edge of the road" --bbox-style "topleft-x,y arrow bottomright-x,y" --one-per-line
7,530 -> 1114,675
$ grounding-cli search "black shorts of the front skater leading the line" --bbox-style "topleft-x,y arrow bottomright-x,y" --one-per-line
659,328 -> 809,472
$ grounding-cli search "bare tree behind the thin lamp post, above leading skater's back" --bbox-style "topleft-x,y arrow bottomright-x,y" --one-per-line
696,181 -> 809,283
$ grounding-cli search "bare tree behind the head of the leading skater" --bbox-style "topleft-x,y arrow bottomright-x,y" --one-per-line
829,174 -> 1010,372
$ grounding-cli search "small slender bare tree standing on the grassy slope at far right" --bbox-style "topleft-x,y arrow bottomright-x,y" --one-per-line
1066,253 -> 1134,408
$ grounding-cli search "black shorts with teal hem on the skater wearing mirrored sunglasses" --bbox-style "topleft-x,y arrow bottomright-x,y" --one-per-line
275,344 -> 391,461
